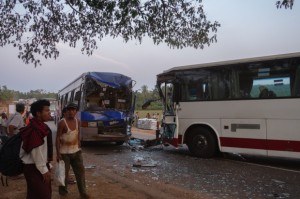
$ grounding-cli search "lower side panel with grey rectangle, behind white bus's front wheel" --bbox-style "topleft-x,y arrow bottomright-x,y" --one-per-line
220,119 -> 267,155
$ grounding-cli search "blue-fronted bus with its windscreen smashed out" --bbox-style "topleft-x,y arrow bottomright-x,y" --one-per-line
58,72 -> 134,145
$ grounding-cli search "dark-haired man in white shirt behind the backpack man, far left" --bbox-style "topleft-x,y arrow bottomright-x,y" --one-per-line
7,103 -> 25,136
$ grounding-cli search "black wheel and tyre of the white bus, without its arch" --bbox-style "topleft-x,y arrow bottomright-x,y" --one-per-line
187,127 -> 217,158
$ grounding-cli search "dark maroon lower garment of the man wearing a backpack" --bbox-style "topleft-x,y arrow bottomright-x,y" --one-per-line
24,164 -> 52,199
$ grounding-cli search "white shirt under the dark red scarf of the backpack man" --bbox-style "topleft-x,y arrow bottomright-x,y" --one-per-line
20,136 -> 49,174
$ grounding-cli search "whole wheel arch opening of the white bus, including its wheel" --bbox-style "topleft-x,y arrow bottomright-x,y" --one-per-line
184,124 -> 219,158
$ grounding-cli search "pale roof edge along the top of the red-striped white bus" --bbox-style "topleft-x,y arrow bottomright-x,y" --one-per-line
159,52 -> 300,75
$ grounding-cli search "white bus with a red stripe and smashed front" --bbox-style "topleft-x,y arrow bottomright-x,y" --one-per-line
157,53 -> 300,158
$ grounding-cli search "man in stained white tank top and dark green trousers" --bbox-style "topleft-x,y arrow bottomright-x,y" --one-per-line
56,103 -> 89,198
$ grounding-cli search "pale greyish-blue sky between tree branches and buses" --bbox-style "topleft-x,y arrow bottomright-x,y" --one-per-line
0,0 -> 300,92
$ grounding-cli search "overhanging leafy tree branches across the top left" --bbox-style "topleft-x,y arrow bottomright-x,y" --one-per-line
0,0 -> 220,66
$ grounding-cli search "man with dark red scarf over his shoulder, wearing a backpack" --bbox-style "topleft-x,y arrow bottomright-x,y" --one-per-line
20,100 -> 53,199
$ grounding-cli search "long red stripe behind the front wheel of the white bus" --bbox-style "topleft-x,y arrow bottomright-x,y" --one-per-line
220,137 -> 300,152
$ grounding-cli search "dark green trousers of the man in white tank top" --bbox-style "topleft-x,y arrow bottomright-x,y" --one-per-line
59,151 -> 86,195
